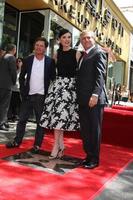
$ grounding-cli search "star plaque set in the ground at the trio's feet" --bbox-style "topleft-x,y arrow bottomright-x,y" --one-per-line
5,151 -> 80,174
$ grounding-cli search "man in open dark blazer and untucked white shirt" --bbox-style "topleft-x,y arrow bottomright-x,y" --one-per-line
6,37 -> 55,153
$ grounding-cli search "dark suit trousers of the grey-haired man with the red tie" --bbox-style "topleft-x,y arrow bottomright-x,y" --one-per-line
79,105 -> 104,162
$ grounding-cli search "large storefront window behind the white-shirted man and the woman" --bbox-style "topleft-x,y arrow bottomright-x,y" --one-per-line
18,9 -> 80,57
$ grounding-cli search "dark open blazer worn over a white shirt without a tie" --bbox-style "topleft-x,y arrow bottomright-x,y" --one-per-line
19,55 -> 56,98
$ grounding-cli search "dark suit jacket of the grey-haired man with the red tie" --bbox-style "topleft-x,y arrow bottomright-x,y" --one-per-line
77,46 -> 107,106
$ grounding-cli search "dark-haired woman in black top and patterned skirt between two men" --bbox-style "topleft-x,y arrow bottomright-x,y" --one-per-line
40,29 -> 81,159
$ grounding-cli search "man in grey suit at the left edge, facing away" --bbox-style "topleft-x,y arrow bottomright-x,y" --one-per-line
0,44 -> 17,131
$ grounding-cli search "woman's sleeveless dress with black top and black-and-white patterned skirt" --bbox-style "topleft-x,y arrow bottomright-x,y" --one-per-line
40,49 -> 79,131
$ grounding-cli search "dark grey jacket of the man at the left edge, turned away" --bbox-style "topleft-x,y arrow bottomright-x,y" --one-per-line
0,54 -> 17,90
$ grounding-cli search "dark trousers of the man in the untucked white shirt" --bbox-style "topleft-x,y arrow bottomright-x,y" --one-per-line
15,94 -> 44,147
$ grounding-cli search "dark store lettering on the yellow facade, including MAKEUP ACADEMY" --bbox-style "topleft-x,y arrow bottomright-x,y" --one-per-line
50,0 -> 124,54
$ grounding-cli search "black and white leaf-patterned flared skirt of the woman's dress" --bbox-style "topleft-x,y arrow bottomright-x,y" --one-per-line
40,77 -> 79,131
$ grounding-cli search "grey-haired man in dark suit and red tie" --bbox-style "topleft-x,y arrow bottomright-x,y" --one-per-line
77,31 -> 107,169
